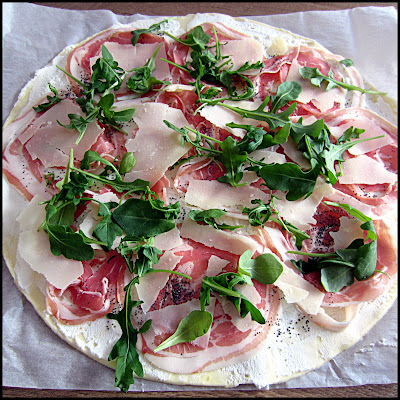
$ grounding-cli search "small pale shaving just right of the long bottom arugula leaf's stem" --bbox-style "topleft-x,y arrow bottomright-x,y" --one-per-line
135,251 -> 182,313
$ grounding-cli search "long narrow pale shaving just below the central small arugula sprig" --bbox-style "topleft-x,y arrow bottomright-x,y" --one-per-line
181,219 -> 261,255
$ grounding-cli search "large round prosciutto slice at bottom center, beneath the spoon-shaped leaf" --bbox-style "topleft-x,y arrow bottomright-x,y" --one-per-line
134,239 -> 280,374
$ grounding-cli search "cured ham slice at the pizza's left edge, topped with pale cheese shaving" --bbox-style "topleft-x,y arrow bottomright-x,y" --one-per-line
3,99 -> 104,200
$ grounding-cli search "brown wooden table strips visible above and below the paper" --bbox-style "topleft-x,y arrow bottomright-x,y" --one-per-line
2,2 -> 398,398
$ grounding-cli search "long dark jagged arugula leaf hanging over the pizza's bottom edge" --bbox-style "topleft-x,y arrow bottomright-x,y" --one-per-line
106,277 -> 152,393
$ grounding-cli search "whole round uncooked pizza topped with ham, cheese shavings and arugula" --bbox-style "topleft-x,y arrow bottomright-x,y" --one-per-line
3,14 -> 397,390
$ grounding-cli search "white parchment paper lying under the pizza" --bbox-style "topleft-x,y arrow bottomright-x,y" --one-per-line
2,3 -> 397,392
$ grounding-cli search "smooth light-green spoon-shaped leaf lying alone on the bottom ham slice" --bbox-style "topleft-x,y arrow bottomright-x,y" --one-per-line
153,310 -> 213,353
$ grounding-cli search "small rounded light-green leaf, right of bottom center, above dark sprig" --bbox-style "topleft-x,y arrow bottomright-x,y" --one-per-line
238,250 -> 283,285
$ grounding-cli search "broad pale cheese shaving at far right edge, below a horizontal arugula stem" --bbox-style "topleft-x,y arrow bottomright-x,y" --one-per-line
339,155 -> 397,185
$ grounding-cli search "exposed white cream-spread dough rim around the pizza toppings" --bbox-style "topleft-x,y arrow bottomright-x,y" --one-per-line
3,14 -> 396,387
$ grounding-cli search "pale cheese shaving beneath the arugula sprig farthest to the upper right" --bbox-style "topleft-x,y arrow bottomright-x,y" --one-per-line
286,59 -> 346,112
